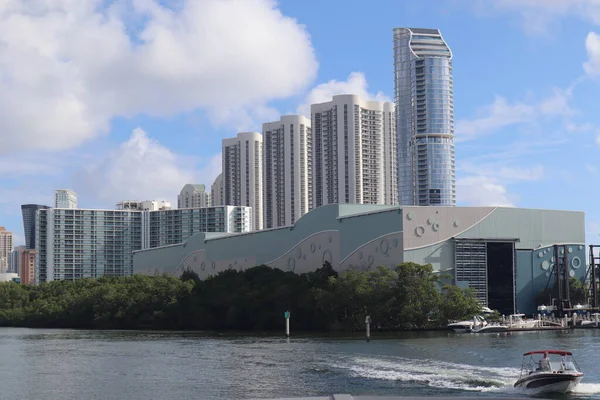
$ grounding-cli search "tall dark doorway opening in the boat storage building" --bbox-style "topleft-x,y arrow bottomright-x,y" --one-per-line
486,242 -> 515,315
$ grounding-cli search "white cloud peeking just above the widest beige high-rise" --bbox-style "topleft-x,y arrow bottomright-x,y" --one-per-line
296,72 -> 392,116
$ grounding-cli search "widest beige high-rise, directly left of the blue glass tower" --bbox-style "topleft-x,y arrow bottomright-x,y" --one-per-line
310,95 -> 397,207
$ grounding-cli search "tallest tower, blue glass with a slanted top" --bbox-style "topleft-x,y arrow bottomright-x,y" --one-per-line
394,28 -> 456,206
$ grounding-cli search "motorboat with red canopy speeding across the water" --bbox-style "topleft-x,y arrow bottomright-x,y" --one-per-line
514,350 -> 583,394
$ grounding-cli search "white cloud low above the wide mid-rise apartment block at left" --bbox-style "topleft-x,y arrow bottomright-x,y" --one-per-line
74,128 -> 221,207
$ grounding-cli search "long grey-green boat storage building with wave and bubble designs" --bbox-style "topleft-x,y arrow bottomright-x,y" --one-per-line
134,204 -> 586,314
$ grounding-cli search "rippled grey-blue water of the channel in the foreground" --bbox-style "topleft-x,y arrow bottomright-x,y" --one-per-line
0,329 -> 600,400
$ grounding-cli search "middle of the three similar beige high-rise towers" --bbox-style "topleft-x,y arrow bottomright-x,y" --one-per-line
263,115 -> 312,229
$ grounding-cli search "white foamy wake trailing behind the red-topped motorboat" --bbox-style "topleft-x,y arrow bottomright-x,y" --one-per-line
333,357 -> 520,392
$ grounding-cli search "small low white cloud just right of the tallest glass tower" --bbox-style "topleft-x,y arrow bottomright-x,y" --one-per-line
456,176 -> 515,207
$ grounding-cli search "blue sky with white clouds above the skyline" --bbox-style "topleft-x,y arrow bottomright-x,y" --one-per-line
0,0 -> 600,245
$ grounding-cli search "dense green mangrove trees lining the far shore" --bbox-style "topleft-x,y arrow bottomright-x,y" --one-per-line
0,262 -> 481,335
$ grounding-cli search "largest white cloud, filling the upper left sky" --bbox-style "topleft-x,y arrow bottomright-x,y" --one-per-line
0,0 -> 317,152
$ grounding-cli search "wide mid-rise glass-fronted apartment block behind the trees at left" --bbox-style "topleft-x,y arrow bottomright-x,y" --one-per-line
35,206 -> 252,283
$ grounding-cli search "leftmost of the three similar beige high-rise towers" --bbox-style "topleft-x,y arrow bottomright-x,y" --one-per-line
222,132 -> 263,230
